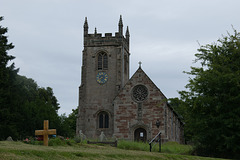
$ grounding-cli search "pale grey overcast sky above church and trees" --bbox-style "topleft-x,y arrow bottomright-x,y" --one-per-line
0,0 -> 240,114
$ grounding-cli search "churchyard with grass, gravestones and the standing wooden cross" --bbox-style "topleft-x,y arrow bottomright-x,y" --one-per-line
0,120 -> 229,160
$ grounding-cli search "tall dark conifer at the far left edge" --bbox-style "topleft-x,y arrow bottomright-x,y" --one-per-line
0,17 -> 18,139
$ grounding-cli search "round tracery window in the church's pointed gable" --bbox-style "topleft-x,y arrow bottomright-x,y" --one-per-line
132,85 -> 148,102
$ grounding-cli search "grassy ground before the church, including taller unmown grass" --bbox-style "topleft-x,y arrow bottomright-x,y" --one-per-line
0,138 -> 227,160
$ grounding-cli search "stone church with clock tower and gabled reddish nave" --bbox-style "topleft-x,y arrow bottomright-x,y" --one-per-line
76,16 -> 184,143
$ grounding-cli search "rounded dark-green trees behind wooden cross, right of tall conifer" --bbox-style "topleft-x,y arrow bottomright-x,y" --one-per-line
12,75 -> 61,138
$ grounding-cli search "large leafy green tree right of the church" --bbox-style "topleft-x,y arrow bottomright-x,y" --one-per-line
179,30 -> 240,158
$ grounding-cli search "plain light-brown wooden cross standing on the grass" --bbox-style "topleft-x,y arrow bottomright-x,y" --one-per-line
35,120 -> 56,146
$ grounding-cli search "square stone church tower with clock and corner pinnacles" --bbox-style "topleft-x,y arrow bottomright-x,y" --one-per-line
77,17 -> 130,137
